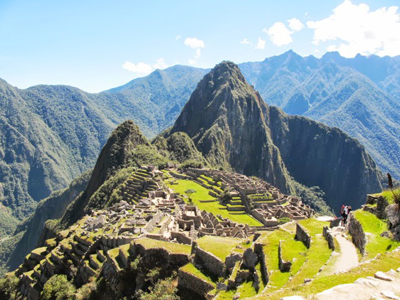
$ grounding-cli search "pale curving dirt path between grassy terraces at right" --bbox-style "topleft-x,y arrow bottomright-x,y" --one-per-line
332,227 -> 358,273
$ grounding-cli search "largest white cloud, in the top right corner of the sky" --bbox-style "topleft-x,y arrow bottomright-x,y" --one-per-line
307,0 -> 400,57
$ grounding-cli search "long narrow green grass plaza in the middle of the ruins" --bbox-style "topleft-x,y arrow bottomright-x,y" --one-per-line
168,179 -> 262,226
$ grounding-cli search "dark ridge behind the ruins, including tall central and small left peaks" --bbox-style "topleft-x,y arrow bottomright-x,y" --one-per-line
3,62 -> 382,268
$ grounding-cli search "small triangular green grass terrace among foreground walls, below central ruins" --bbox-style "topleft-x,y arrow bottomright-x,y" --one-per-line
196,236 -> 243,262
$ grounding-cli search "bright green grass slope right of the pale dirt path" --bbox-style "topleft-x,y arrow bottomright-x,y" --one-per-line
354,210 -> 400,260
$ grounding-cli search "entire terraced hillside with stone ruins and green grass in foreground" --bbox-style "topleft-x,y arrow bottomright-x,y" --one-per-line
0,166 -> 400,300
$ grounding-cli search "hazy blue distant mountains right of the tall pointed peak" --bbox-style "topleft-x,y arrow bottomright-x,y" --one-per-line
239,51 -> 400,178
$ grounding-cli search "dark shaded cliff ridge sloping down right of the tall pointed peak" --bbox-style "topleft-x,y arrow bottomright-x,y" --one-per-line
268,106 -> 382,210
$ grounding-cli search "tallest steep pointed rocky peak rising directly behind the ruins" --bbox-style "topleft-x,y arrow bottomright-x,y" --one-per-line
171,62 -> 290,192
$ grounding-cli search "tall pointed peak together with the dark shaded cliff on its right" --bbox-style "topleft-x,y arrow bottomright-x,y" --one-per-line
171,62 -> 381,209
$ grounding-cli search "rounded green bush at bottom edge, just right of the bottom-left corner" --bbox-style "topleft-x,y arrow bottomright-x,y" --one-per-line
40,275 -> 76,300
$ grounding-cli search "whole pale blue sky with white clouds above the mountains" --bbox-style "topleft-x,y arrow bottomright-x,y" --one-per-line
0,0 -> 400,92
